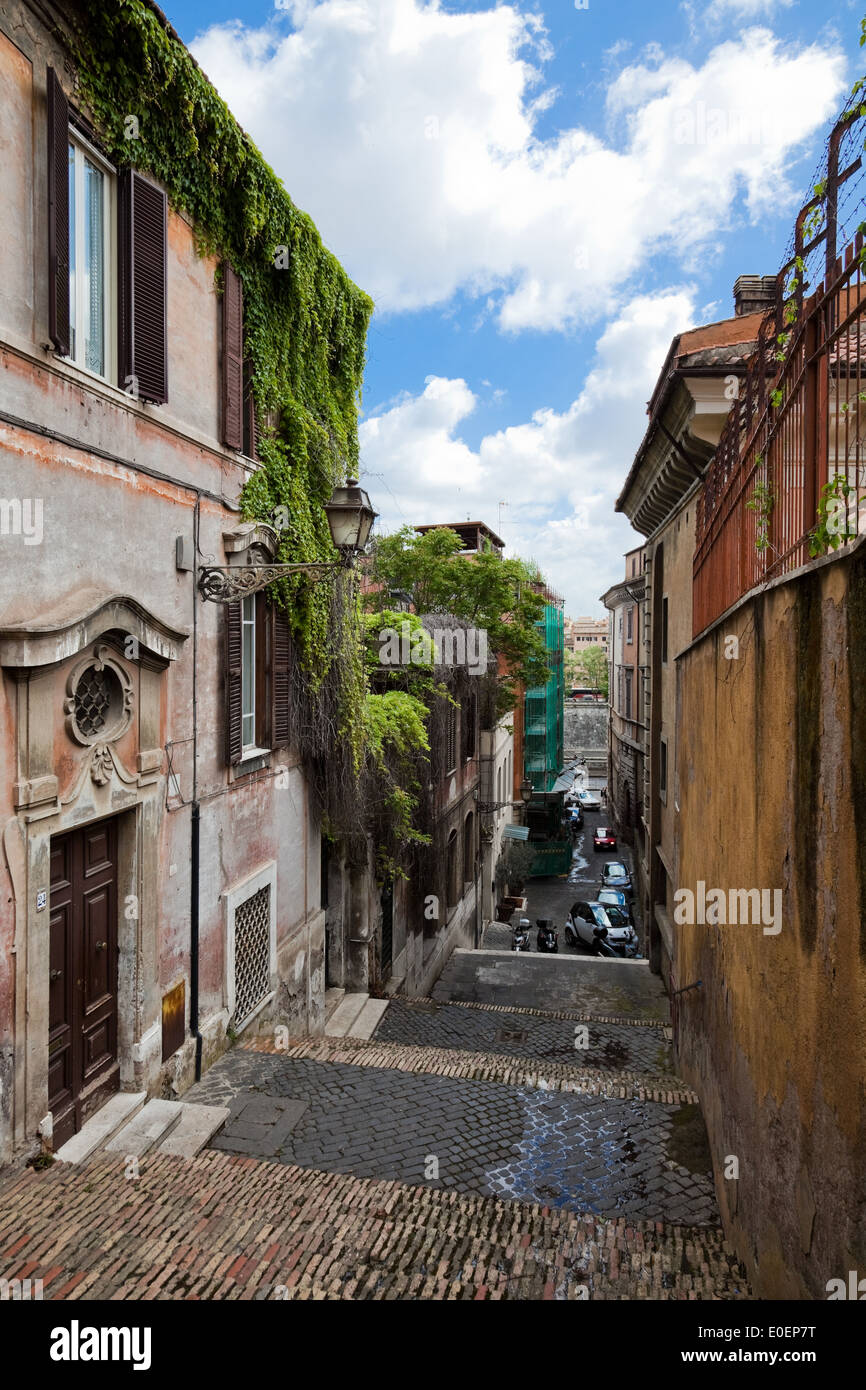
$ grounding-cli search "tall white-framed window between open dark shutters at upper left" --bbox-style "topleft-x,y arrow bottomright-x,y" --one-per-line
68,136 -> 115,378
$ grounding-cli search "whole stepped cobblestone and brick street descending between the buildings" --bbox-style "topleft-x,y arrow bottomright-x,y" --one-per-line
0,952 -> 749,1300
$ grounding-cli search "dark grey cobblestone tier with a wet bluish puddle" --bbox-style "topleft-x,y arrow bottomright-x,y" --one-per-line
188,1049 -> 717,1225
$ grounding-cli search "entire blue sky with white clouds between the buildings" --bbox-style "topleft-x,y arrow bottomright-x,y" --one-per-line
164,0 -> 860,616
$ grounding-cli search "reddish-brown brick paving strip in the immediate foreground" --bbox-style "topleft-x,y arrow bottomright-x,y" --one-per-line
0,1151 -> 751,1295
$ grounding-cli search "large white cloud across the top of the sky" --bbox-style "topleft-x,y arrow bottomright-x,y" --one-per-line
192,0 -> 844,331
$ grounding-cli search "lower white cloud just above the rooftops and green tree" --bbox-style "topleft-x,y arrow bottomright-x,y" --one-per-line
361,288 -> 695,613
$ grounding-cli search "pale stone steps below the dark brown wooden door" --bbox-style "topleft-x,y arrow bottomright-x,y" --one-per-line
54,1091 -> 229,1163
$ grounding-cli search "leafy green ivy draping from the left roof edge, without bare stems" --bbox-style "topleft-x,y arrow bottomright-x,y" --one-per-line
72,0 -> 373,689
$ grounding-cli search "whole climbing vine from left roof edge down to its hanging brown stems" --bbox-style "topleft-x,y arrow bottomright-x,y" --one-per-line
61,0 -> 428,859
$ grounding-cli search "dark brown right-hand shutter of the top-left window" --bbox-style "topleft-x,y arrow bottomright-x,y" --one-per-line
118,170 -> 168,404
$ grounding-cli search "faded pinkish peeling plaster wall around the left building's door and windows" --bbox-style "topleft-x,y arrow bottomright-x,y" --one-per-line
0,0 -> 324,1162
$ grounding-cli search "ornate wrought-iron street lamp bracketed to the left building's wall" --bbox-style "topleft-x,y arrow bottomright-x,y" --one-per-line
199,478 -> 378,603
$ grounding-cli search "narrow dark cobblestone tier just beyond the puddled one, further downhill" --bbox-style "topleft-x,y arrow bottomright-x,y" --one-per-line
375,999 -> 671,1074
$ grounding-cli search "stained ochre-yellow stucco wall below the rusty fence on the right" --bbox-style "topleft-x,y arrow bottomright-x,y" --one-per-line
674,543 -> 866,1298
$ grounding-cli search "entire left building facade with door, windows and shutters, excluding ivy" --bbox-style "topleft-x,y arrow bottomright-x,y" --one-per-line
0,0 -> 339,1159
